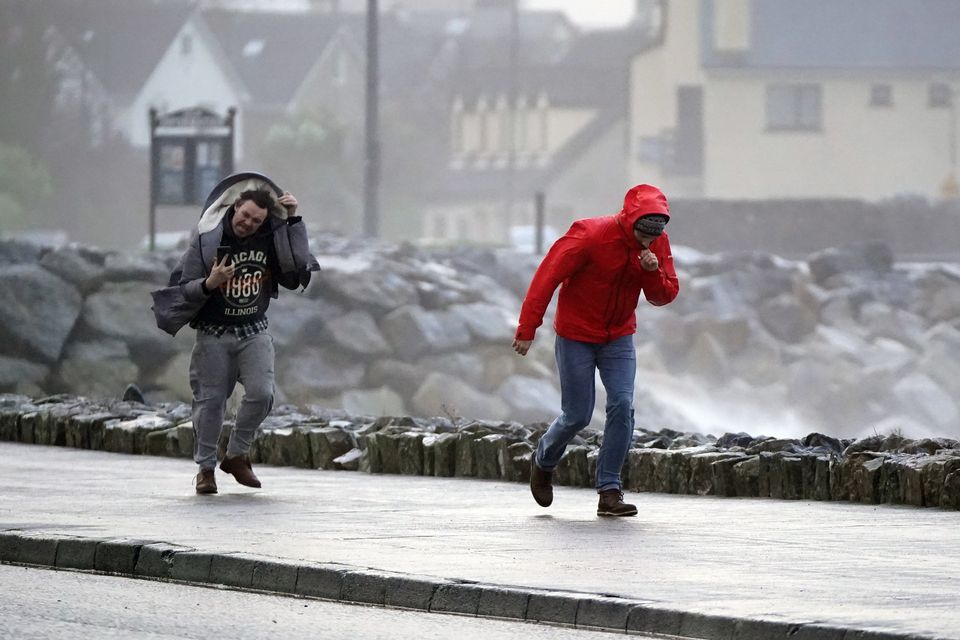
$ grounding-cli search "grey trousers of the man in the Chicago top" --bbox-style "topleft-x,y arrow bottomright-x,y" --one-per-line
190,331 -> 274,469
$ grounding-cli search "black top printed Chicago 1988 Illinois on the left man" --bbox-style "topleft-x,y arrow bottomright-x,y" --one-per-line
196,219 -> 277,324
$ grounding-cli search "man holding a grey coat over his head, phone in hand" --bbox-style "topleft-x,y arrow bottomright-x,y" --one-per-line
154,174 -> 319,494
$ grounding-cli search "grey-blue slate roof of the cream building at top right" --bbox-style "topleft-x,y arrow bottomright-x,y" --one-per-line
701,0 -> 960,70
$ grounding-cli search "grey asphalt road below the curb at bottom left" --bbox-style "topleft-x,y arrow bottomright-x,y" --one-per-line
0,565 -> 650,640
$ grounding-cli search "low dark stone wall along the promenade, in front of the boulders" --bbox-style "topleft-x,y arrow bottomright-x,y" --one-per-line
0,395 -> 960,509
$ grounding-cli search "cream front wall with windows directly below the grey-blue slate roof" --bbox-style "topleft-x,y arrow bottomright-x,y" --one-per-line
704,72 -> 950,200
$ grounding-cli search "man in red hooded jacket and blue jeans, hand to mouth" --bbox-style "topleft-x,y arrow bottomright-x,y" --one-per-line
513,184 -> 679,516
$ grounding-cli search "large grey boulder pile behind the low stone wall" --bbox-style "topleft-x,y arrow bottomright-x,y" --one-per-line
0,236 -> 960,437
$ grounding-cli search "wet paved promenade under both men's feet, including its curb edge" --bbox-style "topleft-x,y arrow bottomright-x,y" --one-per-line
0,443 -> 960,640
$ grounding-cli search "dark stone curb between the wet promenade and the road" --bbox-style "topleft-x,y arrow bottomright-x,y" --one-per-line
0,529 -> 936,640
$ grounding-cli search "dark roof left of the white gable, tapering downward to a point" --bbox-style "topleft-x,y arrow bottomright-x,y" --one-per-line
43,0 -> 193,95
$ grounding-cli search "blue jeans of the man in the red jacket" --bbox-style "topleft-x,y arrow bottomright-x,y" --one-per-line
535,335 -> 637,491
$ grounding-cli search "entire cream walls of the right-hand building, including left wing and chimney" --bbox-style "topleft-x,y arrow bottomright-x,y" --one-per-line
627,0 -> 960,200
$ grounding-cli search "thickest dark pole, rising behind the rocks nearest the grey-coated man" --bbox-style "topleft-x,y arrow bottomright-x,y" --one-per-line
363,0 -> 380,238
